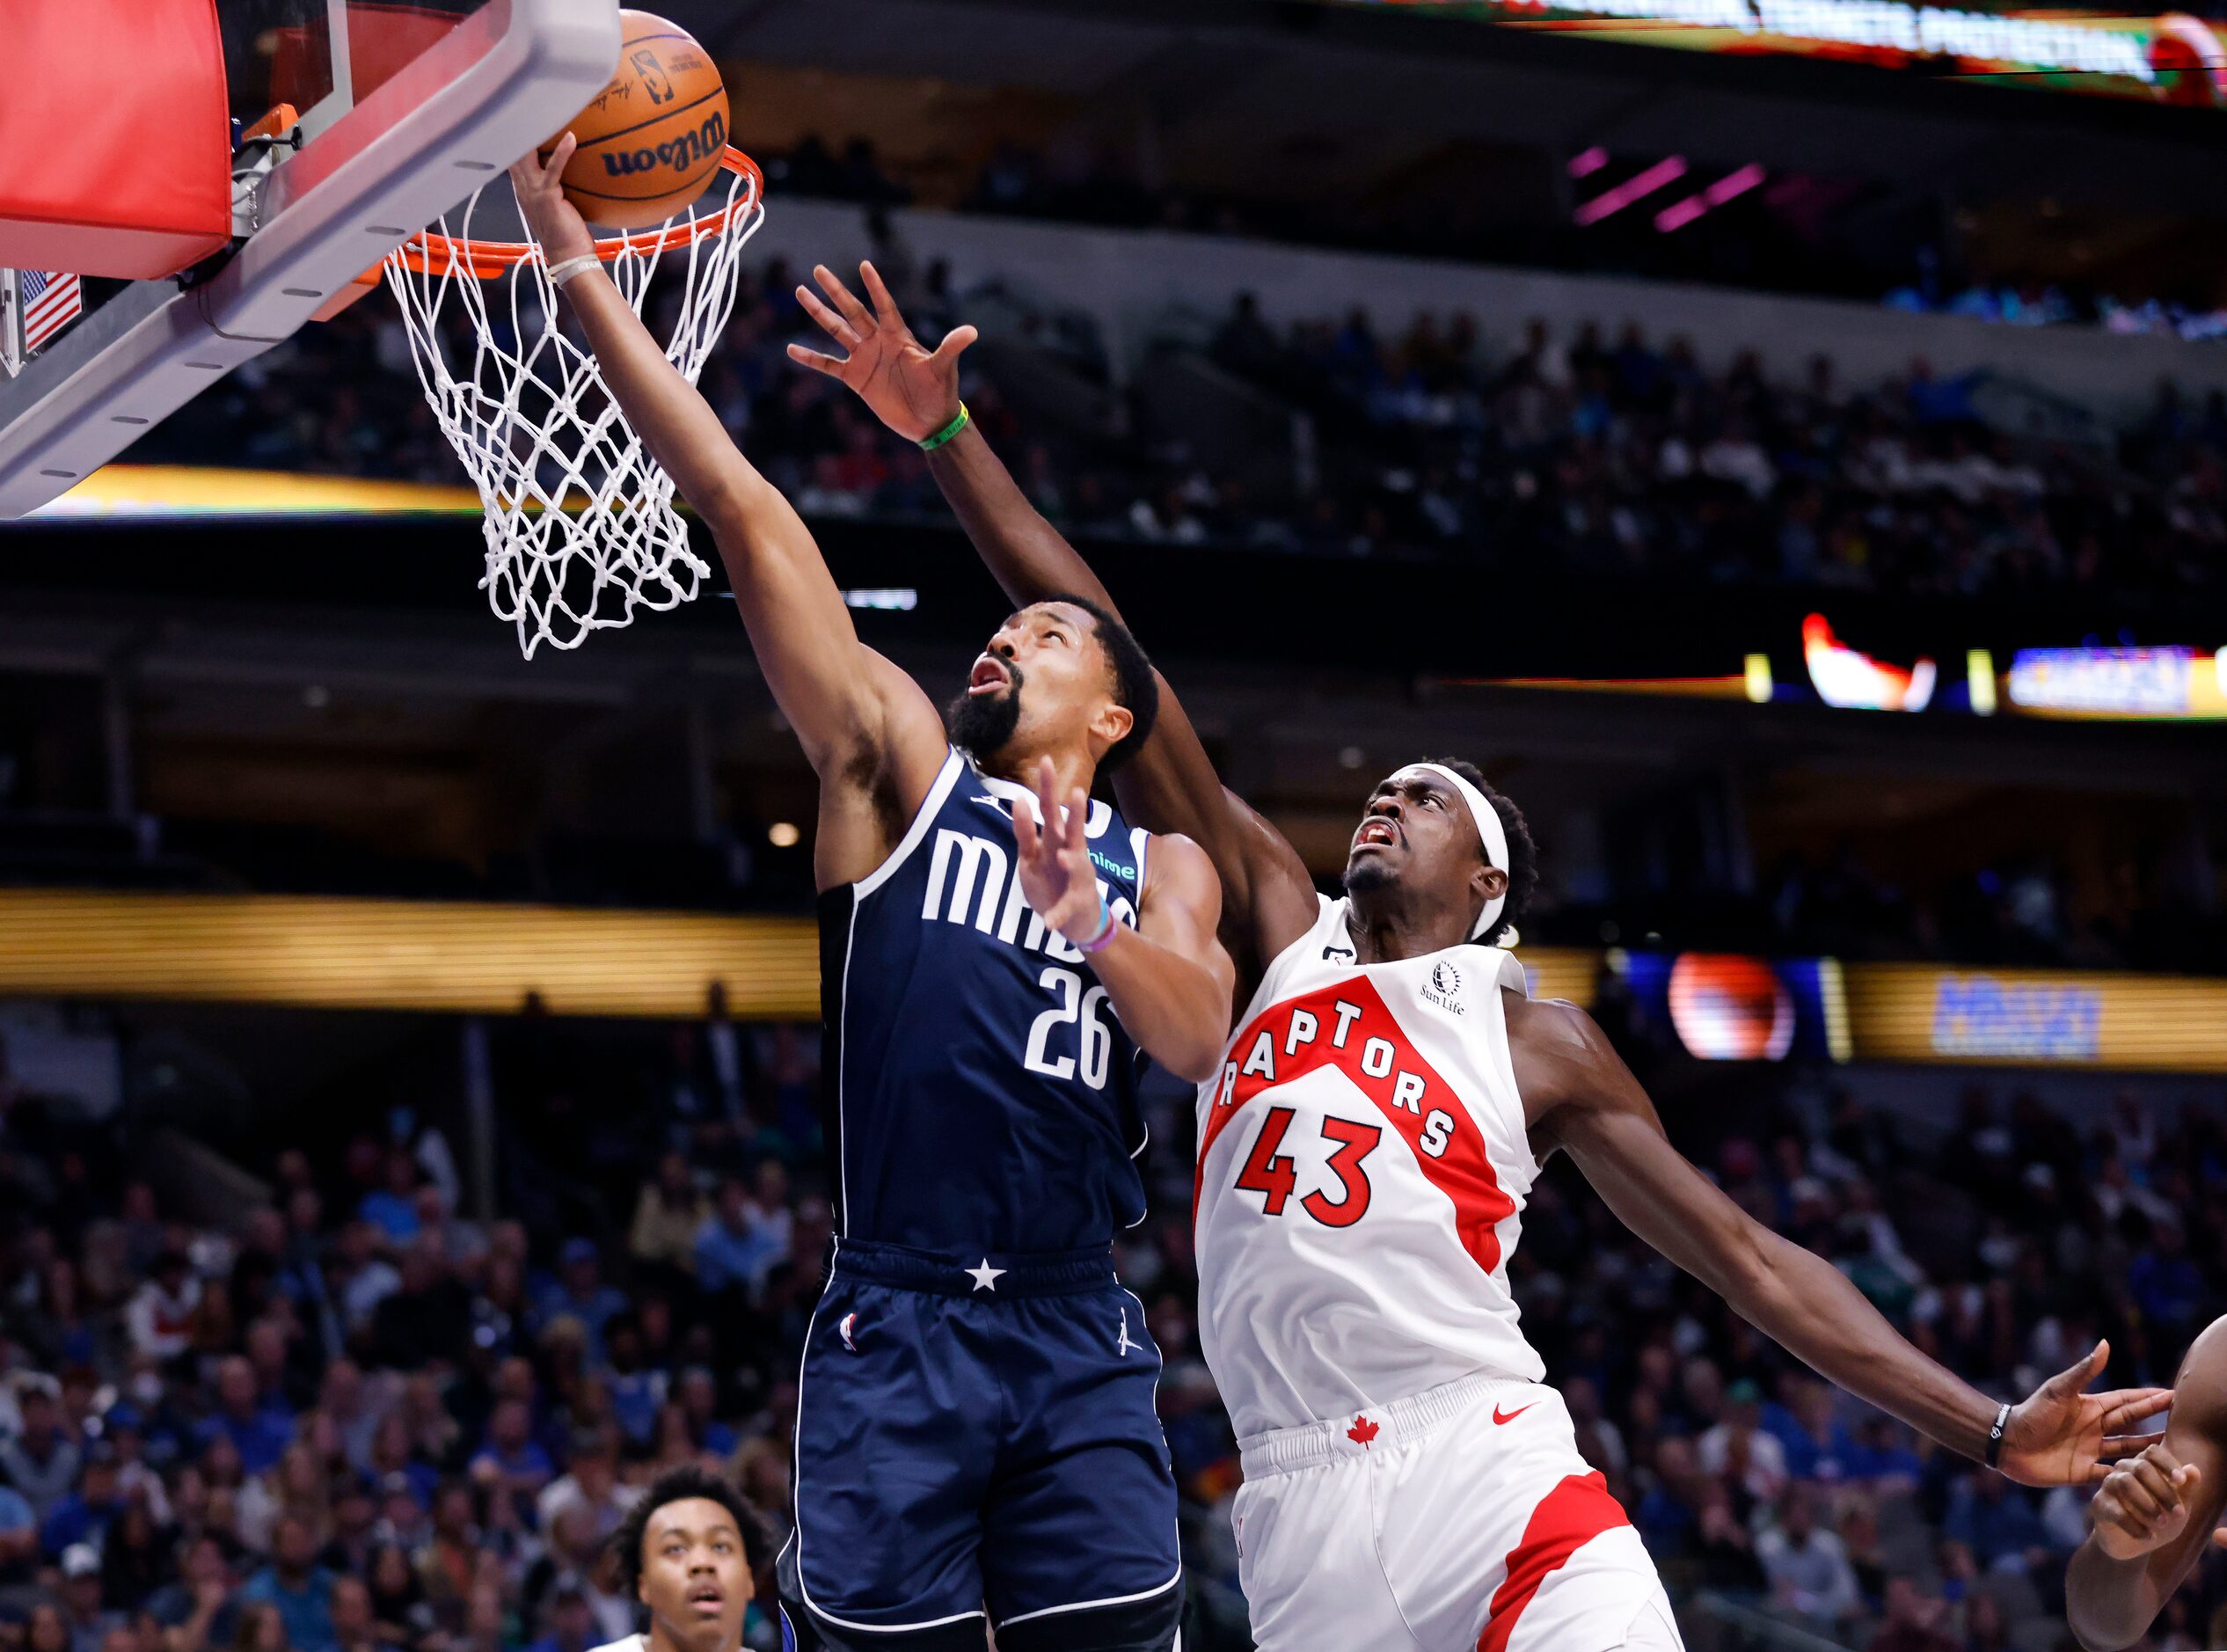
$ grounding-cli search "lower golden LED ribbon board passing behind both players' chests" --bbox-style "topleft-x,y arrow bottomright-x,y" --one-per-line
0,888 -> 2227,1073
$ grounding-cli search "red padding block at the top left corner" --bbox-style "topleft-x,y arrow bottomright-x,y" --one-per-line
0,0 -> 231,281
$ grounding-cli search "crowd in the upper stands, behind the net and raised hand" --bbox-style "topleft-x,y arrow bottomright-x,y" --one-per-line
134,245 -> 2227,601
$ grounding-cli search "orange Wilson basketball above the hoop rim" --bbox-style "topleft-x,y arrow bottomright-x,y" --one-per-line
541,11 -> 726,230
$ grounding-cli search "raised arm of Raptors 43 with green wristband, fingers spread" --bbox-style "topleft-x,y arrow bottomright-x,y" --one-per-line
788,263 -> 1316,983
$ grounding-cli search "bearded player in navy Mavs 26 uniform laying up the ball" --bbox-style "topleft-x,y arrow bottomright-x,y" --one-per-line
512,149 -> 1231,1652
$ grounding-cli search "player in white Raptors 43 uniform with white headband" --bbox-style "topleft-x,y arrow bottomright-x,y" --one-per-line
791,267 -> 2172,1652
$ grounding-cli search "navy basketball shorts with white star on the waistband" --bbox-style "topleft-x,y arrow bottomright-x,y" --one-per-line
779,1240 -> 1182,1652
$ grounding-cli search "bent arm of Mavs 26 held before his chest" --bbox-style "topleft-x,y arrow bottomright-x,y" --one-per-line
1013,757 -> 1234,1085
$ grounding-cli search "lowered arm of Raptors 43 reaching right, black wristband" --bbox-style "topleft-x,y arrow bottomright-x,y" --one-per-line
1508,998 -> 2172,1485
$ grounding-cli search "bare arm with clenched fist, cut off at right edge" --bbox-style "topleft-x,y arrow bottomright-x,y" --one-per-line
2064,1320 -> 2227,1652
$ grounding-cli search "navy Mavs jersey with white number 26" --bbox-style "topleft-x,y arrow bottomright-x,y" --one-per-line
820,750 -> 1150,1251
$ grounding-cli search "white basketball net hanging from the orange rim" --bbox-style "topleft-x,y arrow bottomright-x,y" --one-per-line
385,161 -> 763,659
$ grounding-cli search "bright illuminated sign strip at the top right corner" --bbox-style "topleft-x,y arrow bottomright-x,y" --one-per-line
1327,0 -> 2227,106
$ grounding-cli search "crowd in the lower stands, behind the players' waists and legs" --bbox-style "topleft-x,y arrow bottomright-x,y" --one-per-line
0,984 -> 2227,1652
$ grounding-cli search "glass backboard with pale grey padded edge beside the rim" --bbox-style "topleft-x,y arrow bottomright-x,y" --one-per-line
0,0 -> 619,521
